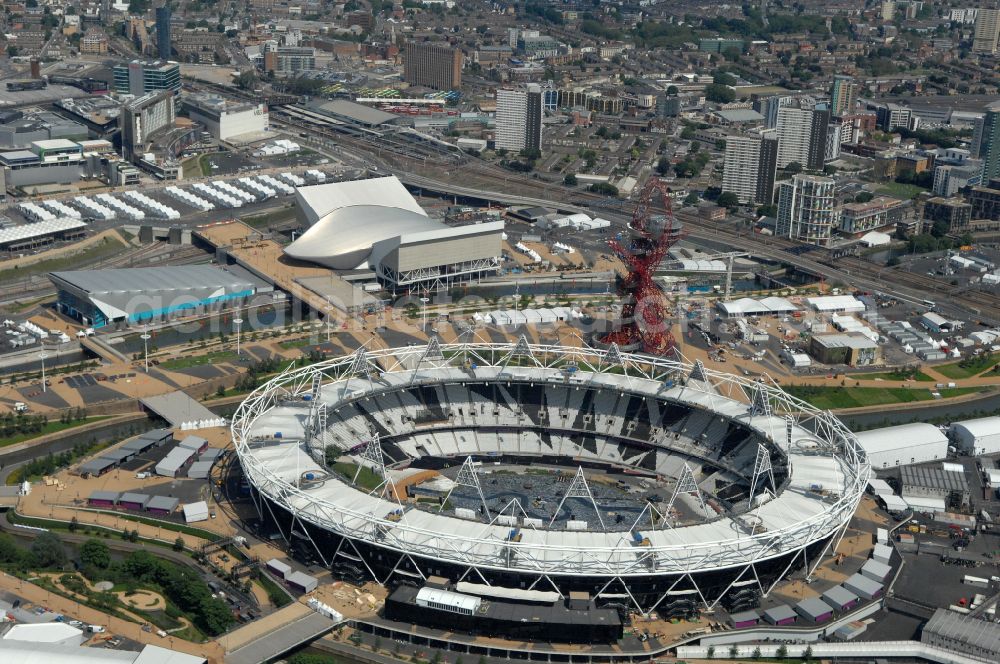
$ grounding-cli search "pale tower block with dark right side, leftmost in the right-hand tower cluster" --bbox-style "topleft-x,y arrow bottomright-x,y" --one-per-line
722,130 -> 778,204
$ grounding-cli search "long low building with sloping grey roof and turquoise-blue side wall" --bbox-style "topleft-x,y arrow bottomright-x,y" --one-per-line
49,265 -> 270,328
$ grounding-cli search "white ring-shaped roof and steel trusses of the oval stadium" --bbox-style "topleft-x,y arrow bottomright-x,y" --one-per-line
232,337 -> 870,611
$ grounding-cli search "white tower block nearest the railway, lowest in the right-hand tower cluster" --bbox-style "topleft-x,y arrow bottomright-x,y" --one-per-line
776,174 -> 837,246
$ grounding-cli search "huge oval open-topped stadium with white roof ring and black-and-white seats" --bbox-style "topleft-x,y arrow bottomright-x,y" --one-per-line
232,337 -> 871,616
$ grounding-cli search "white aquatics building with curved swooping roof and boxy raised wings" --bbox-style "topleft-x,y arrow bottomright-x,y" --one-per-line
285,176 -> 503,289
